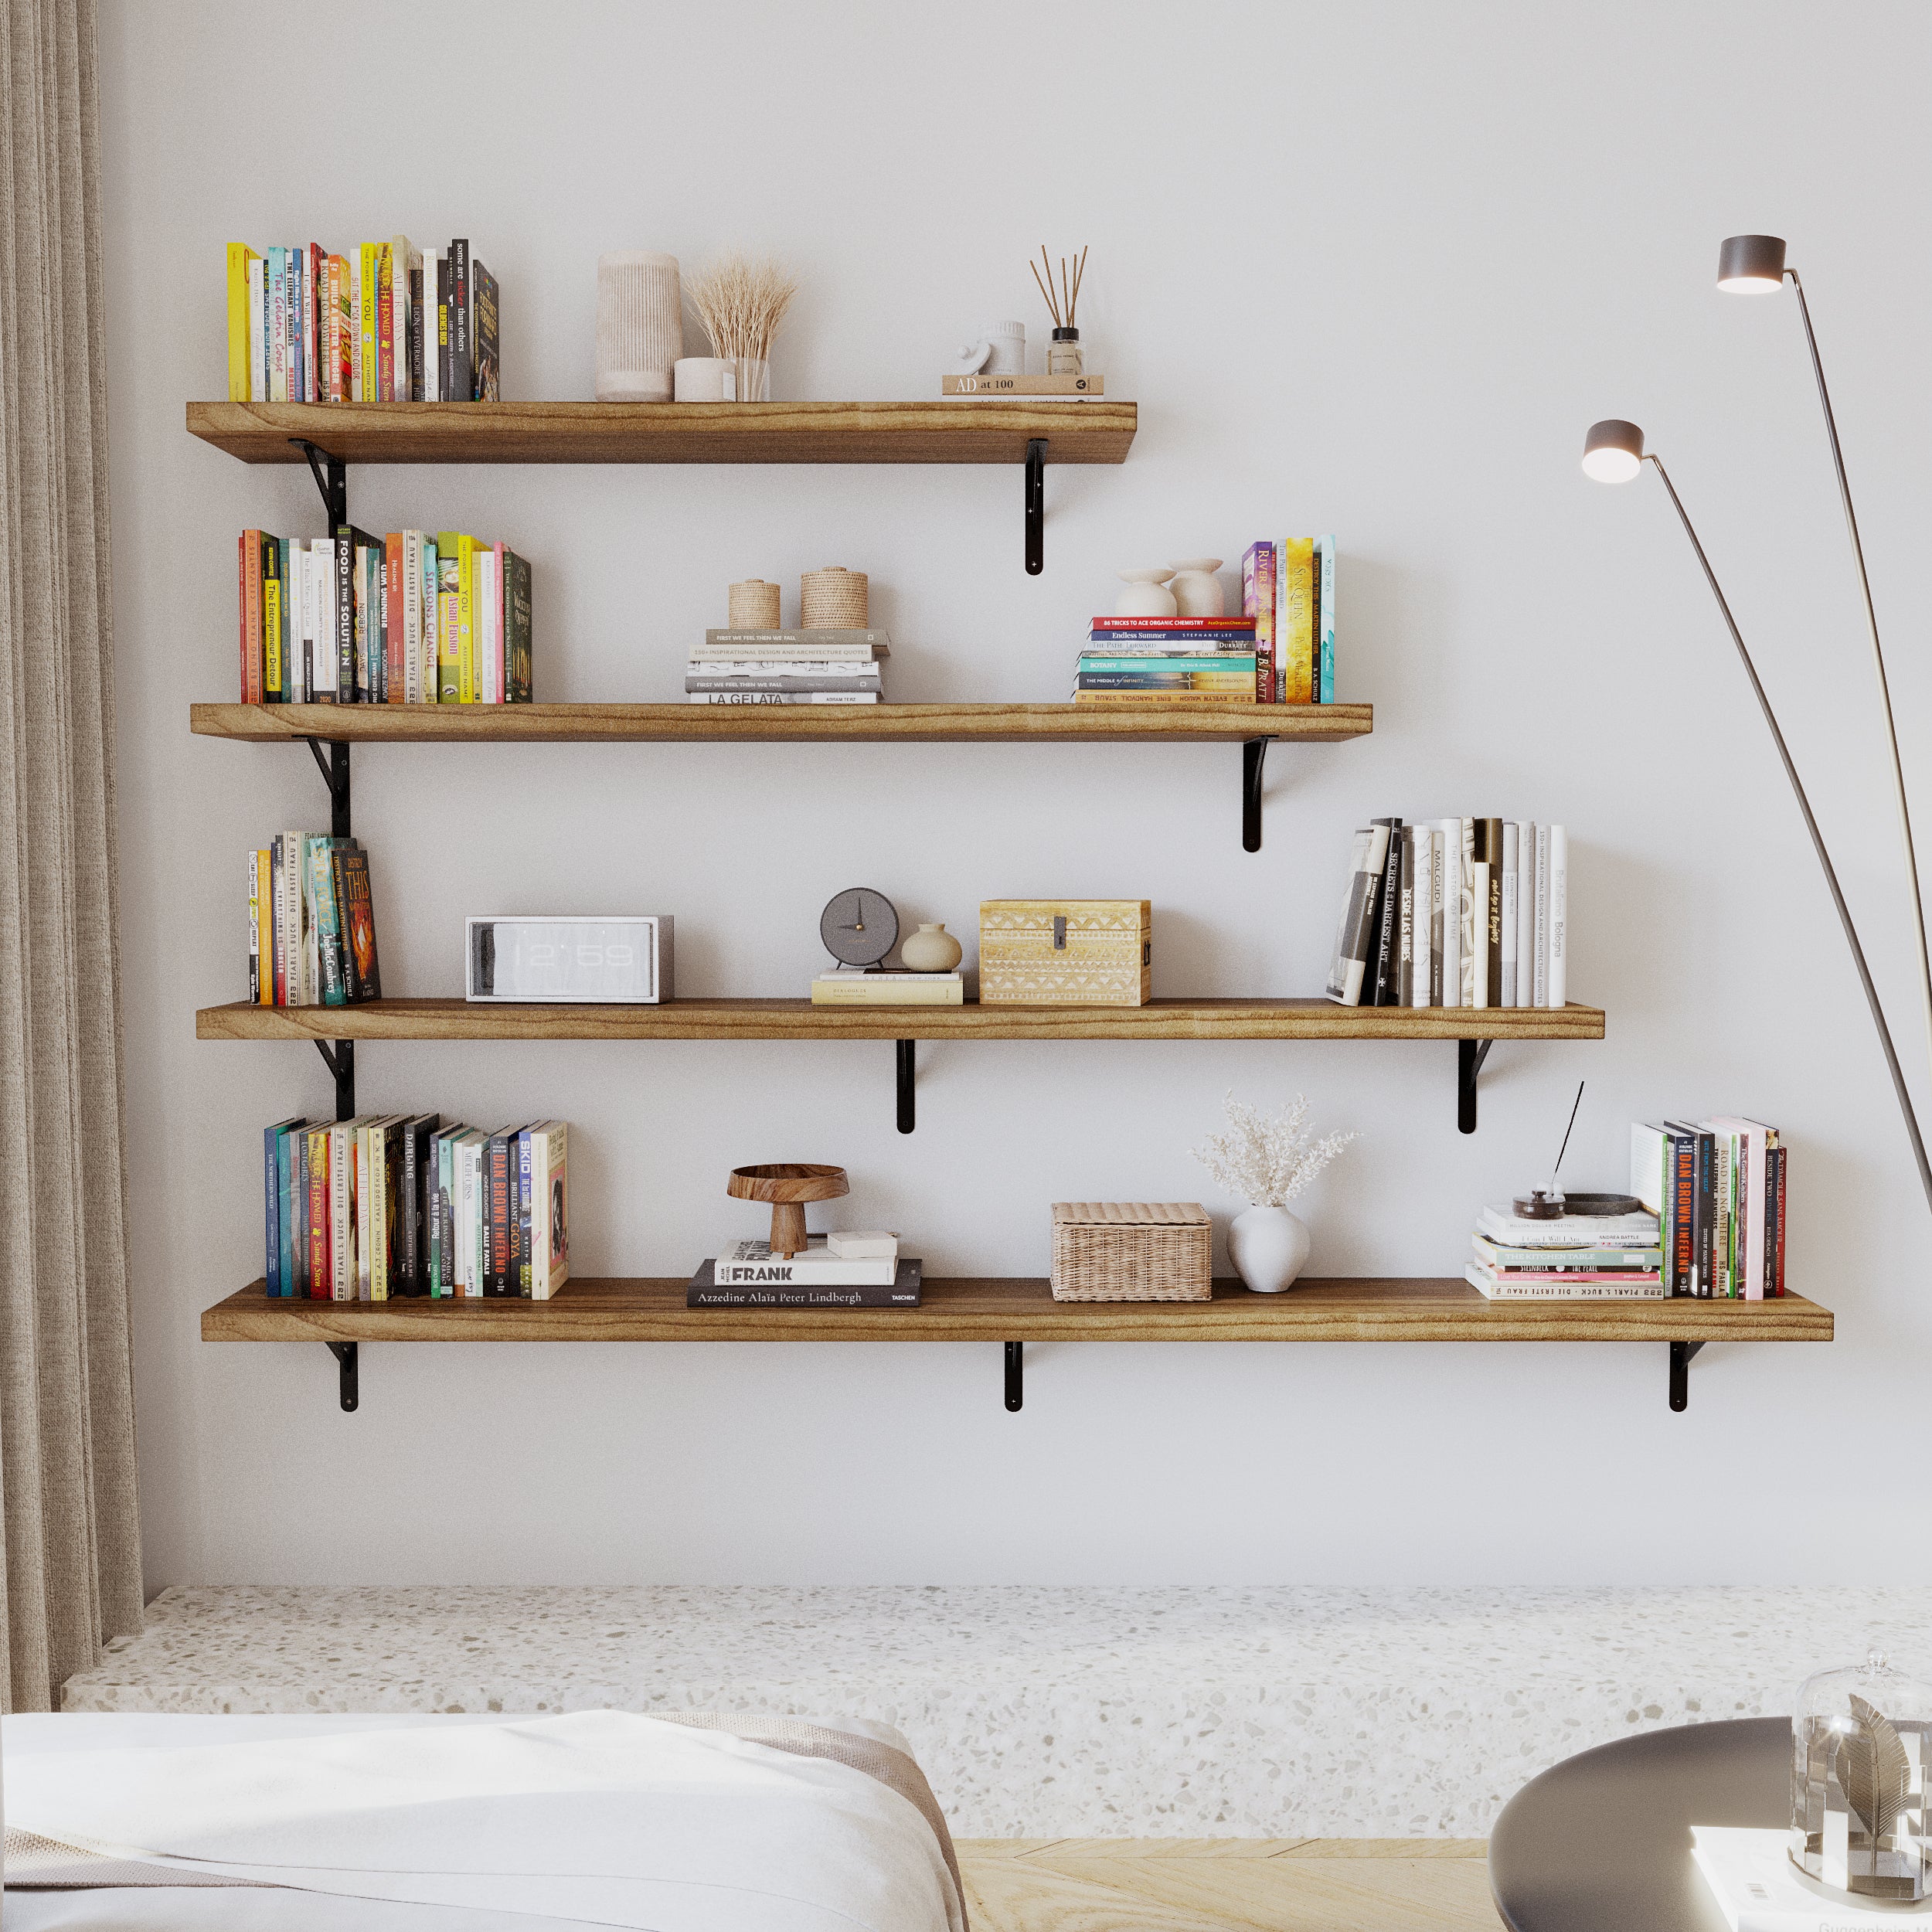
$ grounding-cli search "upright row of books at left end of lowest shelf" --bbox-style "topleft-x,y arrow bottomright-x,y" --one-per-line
263,1113 -> 570,1302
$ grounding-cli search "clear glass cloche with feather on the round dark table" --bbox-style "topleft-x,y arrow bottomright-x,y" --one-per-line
1791,1650 -> 1932,1903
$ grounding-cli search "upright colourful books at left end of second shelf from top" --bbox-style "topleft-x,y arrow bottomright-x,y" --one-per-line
238,524 -> 533,706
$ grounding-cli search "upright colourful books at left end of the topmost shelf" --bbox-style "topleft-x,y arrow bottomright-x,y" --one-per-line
228,236 -> 501,402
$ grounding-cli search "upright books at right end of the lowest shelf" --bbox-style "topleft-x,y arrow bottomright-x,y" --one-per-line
1631,1115 -> 1789,1302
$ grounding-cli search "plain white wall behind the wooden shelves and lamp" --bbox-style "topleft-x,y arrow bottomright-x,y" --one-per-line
100,0 -> 1932,1588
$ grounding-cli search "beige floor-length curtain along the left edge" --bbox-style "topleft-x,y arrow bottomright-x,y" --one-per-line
0,0 -> 141,1710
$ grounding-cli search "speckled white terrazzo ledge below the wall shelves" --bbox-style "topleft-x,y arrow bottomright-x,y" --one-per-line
64,1587 -> 1932,1839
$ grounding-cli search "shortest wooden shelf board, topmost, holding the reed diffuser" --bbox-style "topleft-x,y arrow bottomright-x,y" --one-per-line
188,396 -> 1136,464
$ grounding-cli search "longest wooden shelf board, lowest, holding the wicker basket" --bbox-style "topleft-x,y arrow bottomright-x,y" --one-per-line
201,1279 -> 1832,1343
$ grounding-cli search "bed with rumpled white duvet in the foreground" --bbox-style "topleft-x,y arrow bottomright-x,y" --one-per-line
0,1712 -> 966,1932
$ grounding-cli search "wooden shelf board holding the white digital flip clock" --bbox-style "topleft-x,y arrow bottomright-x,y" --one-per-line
196,999 -> 1604,1039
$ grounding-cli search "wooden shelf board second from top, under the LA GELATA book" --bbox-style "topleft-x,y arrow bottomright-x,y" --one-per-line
188,699 -> 1376,744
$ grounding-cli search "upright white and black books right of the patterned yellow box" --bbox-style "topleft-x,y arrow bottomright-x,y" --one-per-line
1328,819 -> 1569,1007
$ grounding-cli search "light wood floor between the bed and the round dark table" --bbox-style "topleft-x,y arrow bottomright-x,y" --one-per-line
958,1838 -> 1502,1932
